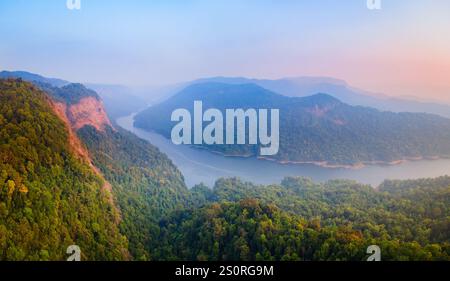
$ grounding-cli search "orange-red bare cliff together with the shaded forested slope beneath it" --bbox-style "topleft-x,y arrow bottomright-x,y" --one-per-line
0,75 -> 192,260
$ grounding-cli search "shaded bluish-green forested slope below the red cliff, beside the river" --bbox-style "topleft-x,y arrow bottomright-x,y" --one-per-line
78,126 -> 189,260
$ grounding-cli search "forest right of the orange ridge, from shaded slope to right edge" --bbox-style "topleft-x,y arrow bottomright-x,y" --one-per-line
80,118 -> 450,260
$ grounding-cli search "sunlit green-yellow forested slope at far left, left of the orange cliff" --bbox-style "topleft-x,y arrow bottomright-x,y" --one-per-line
0,79 -> 129,260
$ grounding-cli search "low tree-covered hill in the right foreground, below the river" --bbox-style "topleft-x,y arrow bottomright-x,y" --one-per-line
154,177 -> 450,261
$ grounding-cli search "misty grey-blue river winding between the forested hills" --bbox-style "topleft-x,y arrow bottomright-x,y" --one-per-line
116,114 -> 450,187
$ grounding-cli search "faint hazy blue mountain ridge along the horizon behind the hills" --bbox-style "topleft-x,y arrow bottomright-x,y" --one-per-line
6,71 -> 450,118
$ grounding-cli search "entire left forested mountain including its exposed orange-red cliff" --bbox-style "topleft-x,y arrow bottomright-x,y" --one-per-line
0,79 -> 189,260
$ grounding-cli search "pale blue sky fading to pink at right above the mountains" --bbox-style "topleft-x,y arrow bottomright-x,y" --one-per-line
0,0 -> 450,103
